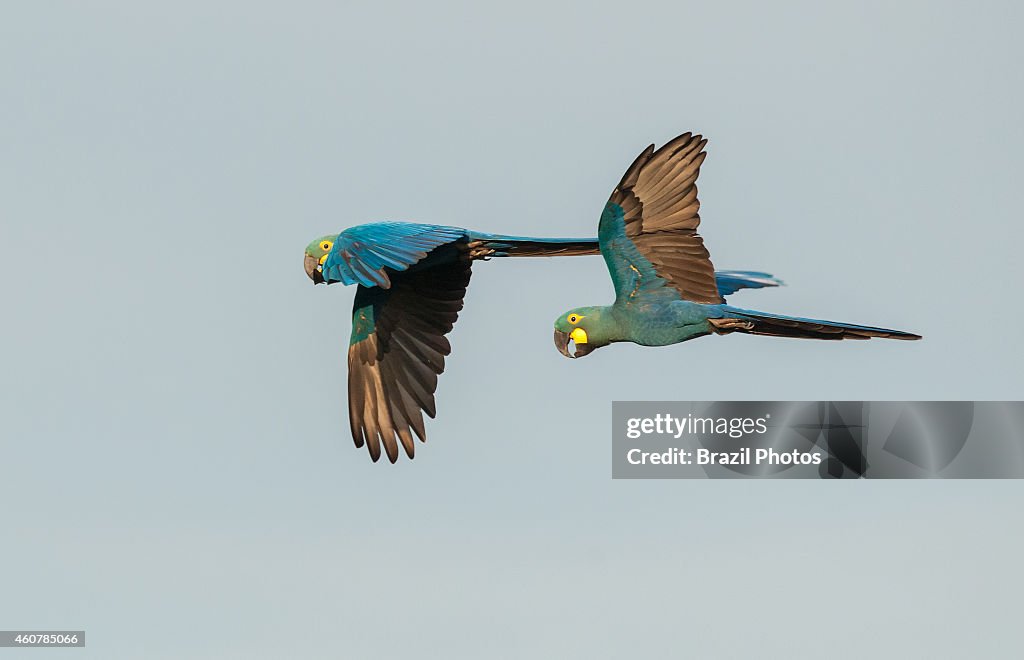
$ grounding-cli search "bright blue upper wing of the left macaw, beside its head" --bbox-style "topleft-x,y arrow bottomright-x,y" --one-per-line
323,222 -> 466,289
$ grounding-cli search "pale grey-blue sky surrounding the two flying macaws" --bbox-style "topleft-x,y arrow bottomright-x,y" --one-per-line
0,2 -> 1024,659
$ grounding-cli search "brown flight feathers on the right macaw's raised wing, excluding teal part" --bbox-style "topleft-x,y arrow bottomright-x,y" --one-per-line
609,133 -> 723,303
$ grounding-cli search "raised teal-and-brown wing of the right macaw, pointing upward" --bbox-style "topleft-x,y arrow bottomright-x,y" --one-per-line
598,133 -> 723,303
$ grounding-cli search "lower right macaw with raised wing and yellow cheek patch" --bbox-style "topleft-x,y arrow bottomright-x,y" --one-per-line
555,133 -> 921,358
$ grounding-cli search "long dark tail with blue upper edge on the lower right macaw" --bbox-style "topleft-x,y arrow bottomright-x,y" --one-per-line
710,305 -> 921,340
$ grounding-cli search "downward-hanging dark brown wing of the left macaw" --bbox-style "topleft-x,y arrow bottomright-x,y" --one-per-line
348,261 -> 470,463
